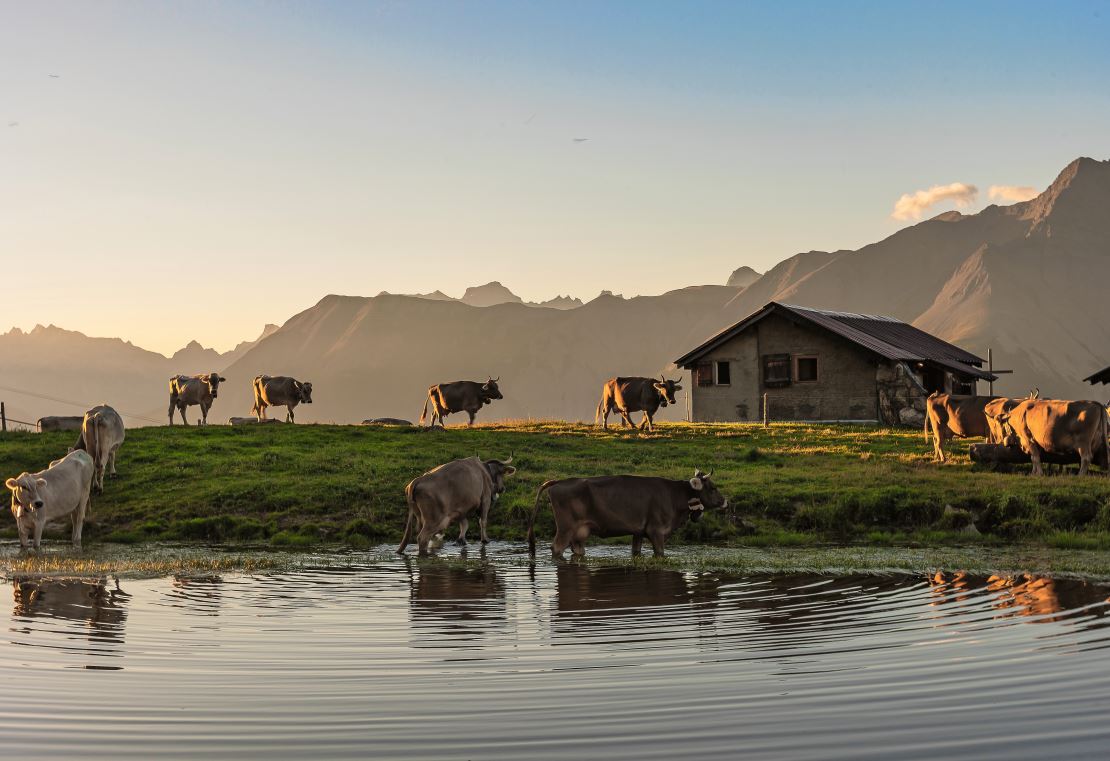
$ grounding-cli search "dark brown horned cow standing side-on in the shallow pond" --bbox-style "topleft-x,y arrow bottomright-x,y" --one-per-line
528,470 -> 728,558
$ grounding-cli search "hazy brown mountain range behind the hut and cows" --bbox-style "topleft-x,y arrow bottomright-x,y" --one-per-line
0,159 -> 1110,425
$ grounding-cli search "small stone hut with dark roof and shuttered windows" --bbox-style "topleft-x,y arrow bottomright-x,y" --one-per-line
675,302 -> 997,425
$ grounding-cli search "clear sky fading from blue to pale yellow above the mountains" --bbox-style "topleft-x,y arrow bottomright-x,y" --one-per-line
0,0 -> 1110,354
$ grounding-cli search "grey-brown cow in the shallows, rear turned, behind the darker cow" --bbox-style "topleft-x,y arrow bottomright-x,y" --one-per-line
397,456 -> 516,555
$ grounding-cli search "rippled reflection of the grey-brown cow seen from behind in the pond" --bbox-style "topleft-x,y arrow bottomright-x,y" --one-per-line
408,562 -> 507,648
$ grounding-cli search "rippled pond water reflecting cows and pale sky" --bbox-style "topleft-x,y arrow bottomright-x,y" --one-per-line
0,548 -> 1110,760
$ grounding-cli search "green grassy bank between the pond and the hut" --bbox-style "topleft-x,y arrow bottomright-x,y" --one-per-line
0,422 -> 1110,550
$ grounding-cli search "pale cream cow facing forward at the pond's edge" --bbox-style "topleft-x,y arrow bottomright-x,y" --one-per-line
4,449 -> 97,549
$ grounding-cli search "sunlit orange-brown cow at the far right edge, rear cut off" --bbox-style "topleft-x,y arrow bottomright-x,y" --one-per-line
996,399 -> 1110,476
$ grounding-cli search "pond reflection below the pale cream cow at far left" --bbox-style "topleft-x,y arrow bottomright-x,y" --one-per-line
12,576 -> 131,642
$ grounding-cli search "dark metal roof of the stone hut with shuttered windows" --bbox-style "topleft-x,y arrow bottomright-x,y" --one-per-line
675,302 -> 999,381
